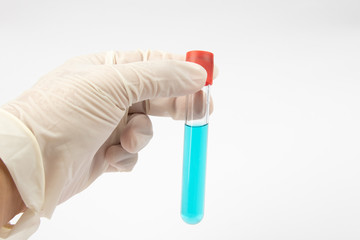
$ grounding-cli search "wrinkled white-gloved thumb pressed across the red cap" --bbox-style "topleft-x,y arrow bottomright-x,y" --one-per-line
101,60 -> 207,106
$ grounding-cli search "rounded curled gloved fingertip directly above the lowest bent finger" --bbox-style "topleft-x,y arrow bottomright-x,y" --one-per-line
120,114 -> 153,153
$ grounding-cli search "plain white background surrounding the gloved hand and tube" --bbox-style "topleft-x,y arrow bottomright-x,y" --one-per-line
0,0 -> 360,240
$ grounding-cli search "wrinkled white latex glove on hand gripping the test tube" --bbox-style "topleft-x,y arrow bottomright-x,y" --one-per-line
2,51 -> 211,238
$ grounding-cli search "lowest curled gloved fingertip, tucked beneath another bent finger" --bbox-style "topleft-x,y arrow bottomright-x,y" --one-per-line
105,145 -> 138,172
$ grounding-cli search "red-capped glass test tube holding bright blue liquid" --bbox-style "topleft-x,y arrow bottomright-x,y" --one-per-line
181,51 -> 214,224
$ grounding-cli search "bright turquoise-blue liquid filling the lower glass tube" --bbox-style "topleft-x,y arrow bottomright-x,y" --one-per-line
181,124 -> 208,224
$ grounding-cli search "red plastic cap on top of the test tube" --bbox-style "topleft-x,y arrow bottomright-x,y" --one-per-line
186,51 -> 214,86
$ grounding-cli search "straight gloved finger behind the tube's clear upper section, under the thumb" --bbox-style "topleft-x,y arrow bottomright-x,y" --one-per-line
129,92 -> 214,120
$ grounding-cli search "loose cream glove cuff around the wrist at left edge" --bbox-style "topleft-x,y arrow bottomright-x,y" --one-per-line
0,109 -> 45,239
